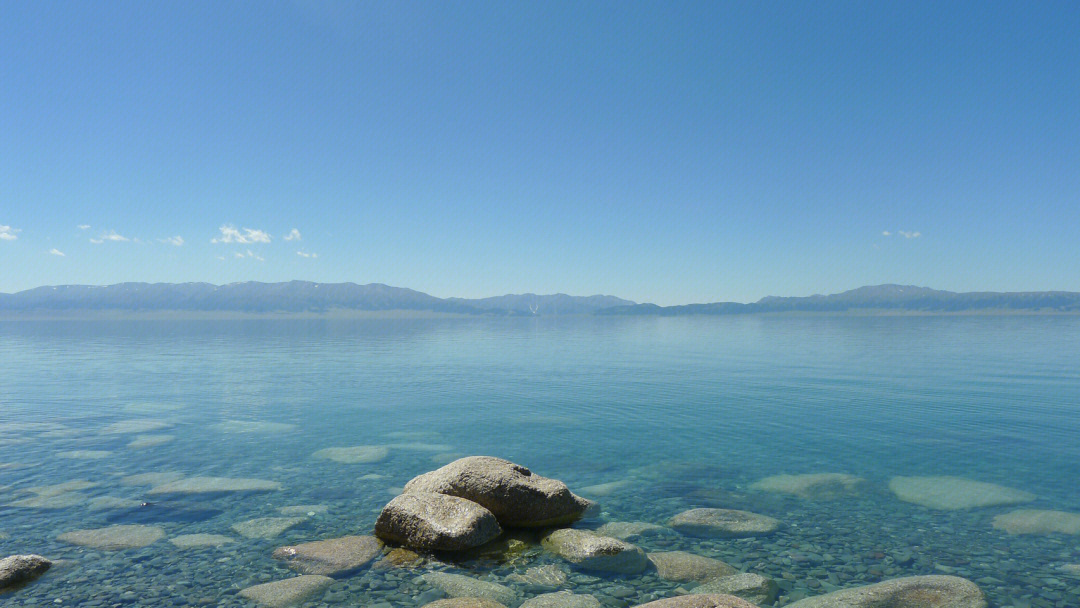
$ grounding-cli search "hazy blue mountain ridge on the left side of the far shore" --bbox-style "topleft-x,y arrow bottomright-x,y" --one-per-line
0,281 -> 634,314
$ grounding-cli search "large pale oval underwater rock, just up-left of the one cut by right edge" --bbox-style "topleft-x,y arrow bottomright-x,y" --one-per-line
889,476 -> 1036,511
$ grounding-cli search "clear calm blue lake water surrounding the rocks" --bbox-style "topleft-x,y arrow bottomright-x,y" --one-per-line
0,316 -> 1080,608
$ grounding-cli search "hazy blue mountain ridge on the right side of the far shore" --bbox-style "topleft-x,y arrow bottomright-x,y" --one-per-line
598,285 -> 1080,316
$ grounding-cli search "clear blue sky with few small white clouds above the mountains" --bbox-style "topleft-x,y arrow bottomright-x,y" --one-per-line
0,0 -> 1080,305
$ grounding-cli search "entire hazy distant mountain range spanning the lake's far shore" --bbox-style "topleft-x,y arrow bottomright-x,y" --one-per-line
0,281 -> 1080,317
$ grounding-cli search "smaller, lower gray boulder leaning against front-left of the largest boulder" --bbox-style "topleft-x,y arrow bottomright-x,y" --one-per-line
375,491 -> 502,551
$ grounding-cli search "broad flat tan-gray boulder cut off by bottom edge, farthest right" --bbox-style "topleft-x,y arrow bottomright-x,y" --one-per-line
787,576 -> 987,608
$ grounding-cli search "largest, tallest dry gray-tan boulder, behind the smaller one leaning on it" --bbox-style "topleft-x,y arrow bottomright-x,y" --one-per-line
405,456 -> 592,527
